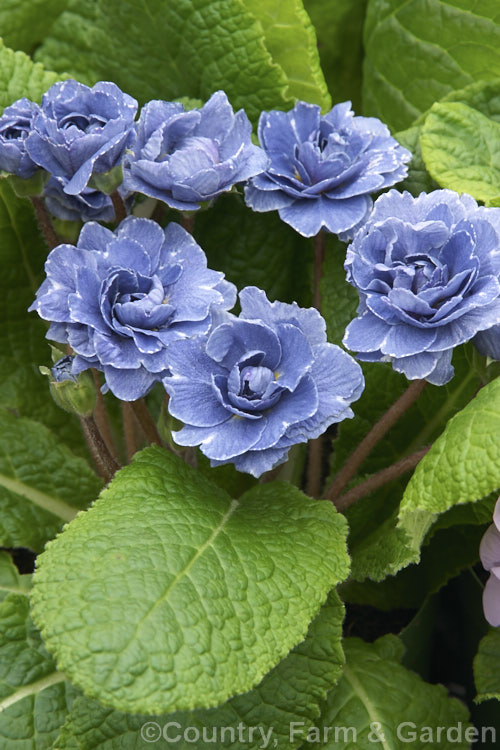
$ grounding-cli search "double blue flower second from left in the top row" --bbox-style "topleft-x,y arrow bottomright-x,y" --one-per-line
26,80 -> 137,195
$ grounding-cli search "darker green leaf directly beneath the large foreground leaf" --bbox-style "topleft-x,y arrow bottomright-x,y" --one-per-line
53,592 -> 344,750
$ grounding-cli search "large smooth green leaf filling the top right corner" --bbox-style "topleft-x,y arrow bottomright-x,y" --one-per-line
363,0 -> 500,130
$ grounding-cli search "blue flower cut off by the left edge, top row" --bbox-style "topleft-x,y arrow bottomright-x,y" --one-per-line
0,99 -> 40,179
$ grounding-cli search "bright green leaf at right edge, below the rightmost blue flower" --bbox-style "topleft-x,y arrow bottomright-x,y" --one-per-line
398,378 -> 500,549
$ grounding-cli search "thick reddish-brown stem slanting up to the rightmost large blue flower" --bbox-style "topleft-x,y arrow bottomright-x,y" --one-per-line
324,380 -> 427,502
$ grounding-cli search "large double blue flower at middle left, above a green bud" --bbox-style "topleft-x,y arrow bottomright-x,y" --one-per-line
30,217 -> 236,401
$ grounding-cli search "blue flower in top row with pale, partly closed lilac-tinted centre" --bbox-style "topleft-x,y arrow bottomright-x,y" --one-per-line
124,91 -> 268,211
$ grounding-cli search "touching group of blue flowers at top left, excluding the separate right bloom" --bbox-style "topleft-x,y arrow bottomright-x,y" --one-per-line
0,80 -> 268,221
